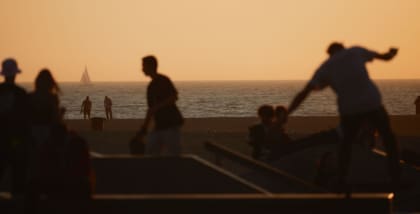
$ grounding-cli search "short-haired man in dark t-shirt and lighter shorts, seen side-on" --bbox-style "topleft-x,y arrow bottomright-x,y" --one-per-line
138,56 -> 184,155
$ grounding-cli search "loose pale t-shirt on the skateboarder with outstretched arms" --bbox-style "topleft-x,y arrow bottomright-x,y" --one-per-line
310,47 -> 382,115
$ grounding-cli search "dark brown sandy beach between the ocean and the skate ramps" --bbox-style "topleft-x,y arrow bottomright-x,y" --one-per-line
66,115 -> 420,159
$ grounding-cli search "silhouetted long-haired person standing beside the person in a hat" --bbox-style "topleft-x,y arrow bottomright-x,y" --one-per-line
28,69 -> 90,212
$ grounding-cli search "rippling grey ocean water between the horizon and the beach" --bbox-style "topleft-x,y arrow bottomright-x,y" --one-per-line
22,80 -> 420,119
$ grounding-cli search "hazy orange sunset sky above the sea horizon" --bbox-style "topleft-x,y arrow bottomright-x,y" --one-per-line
0,0 -> 420,81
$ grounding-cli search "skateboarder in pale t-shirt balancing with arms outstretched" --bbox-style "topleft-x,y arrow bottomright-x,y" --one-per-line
289,43 -> 401,191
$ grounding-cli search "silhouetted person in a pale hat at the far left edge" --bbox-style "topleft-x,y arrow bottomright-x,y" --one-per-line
0,58 -> 29,196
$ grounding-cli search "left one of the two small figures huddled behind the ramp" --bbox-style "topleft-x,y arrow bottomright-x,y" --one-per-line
248,105 -> 274,159
